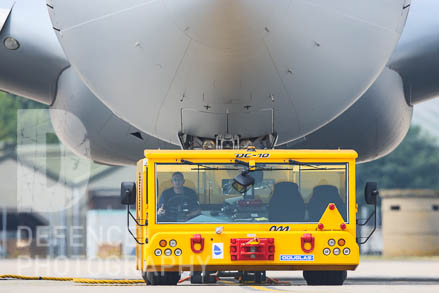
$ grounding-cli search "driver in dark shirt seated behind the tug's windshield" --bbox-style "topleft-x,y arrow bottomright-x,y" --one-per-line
157,172 -> 201,222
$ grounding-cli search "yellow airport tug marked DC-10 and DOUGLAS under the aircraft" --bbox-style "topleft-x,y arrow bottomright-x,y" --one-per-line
121,147 -> 378,285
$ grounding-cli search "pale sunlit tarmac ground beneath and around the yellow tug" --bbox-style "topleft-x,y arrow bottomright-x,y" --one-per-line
0,258 -> 439,293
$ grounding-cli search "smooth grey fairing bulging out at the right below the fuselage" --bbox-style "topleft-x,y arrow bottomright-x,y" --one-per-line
278,68 -> 413,162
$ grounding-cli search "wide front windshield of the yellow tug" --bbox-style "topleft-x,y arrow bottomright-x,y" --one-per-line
155,161 -> 348,224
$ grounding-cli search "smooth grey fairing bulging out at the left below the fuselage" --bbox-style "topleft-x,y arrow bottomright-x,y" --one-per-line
50,68 -> 178,165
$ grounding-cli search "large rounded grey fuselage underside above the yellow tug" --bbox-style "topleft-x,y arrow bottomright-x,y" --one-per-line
48,0 -> 407,143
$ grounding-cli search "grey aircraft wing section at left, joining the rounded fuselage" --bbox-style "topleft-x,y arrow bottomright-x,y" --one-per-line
0,0 -> 69,105
